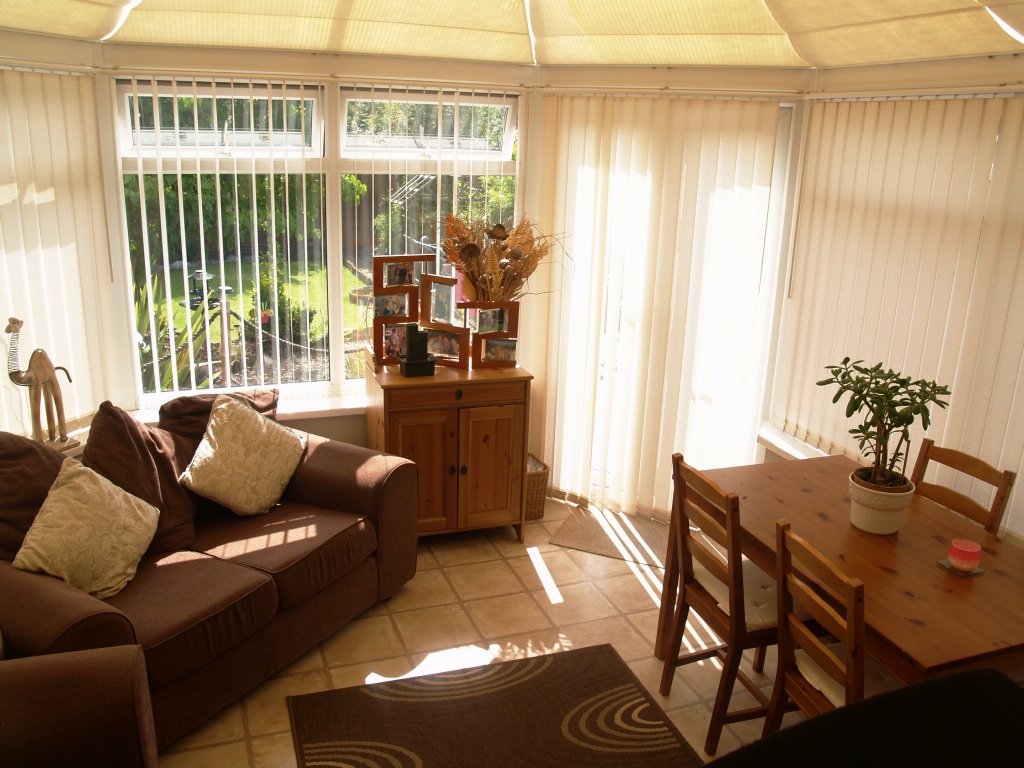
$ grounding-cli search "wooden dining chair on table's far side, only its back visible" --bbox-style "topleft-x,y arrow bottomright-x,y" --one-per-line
910,437 -> 1017,534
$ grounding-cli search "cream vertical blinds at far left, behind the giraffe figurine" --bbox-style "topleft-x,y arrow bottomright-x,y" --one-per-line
0,70 -> 112,434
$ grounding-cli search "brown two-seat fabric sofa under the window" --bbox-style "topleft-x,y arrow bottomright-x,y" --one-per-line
0,390 -> 417,749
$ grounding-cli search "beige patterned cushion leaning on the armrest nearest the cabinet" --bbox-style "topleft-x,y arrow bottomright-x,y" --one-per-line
180,395 -> 306,515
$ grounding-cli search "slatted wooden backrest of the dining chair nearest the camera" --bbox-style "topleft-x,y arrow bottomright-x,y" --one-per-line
775,520 -> 864,712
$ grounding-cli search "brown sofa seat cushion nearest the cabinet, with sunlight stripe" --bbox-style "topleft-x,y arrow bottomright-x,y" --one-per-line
195,502 -> 377,608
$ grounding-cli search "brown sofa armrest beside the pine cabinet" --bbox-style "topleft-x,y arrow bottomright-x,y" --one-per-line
285,435 -> 419,600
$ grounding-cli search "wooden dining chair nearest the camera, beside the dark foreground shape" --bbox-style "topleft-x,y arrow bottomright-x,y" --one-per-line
762,520 -> 899,736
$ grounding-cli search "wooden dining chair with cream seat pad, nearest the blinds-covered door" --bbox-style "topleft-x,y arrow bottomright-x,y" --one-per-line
655,454 -> 776,755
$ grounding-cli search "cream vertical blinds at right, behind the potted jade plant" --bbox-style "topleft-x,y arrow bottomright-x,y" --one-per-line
772,98 -> 1024,532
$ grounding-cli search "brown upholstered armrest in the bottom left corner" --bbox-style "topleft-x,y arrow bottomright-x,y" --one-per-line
0,645 -> 157,768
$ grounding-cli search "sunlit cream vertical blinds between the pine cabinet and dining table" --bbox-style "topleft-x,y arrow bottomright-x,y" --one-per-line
527,96 -> 779,514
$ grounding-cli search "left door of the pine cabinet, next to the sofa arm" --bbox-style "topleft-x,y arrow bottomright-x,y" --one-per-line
388,409 -> 459,534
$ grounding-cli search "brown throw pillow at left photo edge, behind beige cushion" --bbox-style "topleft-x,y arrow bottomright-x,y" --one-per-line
0,432 -> 65,561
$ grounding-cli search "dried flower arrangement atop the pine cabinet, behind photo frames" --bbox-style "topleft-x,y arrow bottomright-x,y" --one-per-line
444,213 -> 553,301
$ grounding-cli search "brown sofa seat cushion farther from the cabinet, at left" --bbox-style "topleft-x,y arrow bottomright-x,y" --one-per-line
108,552 -> 278,688
